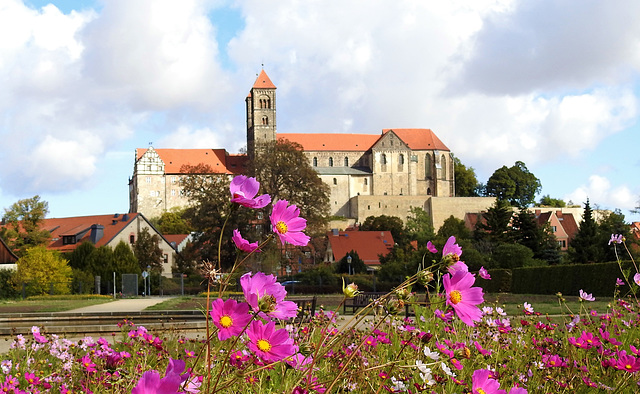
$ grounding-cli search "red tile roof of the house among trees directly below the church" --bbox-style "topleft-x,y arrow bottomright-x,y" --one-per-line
327,231 -> 394,265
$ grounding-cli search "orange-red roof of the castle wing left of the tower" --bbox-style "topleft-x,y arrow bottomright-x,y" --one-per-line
136,148 -> 248,174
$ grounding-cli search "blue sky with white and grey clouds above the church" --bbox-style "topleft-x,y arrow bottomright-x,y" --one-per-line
0,0 -> 640,221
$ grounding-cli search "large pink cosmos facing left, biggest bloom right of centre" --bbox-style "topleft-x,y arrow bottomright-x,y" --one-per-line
442,271 -> 484,326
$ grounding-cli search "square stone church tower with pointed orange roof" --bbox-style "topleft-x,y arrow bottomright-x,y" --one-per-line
246,70 -> 276,160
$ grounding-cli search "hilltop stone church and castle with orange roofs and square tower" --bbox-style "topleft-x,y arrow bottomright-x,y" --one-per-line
129,70 -> 494,229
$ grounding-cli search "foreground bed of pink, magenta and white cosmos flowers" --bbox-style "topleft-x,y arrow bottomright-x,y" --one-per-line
0,176 -> 640,394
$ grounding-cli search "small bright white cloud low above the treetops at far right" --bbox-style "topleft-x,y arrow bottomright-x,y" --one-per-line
563,175 -> 638,209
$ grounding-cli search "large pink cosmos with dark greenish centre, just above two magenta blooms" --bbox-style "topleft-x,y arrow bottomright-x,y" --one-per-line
240,272 -> 298,320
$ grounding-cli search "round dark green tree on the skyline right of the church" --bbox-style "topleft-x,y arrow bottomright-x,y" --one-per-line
486,161 -> 542,208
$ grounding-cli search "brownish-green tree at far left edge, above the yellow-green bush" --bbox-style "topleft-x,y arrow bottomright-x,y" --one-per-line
0,195 -> 51,257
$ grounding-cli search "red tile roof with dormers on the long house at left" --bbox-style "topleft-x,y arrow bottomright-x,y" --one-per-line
40,213 -> 138,252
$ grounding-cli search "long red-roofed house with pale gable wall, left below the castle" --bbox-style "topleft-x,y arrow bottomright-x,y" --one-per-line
40,213 -> 175,277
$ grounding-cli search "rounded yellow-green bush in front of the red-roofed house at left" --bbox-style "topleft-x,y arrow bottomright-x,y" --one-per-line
16,246 -> 71,295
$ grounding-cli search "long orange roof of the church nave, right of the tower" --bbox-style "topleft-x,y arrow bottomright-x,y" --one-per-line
278,133 -> 380,152
